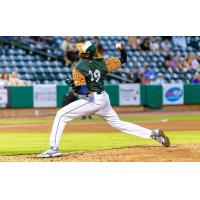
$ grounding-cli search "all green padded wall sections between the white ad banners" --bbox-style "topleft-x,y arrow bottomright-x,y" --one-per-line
8,84 -> 200,108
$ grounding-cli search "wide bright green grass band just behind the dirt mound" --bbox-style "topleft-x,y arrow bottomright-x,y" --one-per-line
0,131 -> 200,155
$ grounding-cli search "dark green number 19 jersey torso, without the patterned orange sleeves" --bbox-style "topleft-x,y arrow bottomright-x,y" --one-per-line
75,58 -> 108,92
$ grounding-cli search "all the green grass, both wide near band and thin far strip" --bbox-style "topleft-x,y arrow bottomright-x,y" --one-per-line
0,115 -> 200,155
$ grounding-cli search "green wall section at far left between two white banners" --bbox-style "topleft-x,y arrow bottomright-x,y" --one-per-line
8,86 -> 33,108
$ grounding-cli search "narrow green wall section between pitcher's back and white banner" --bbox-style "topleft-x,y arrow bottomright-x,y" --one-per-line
104,85 -> 119,106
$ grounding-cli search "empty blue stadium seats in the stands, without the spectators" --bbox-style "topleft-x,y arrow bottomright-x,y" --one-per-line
0,36 -> 200,84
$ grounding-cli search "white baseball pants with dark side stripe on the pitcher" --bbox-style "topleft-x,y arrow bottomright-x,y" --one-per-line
50,92 -> 152,148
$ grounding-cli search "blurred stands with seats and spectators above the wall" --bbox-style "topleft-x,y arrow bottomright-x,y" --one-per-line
0,36 -> 200,84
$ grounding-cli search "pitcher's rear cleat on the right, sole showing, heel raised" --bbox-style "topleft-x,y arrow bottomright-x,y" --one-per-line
151,129 -> 170,147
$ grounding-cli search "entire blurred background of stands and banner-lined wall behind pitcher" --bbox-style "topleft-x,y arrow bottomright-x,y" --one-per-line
0,36 -> 200,114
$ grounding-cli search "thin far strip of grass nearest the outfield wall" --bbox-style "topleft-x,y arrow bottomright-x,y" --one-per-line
0,115 -> 200,125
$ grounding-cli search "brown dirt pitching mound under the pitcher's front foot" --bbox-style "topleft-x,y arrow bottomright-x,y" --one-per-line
0,145 -> 200,162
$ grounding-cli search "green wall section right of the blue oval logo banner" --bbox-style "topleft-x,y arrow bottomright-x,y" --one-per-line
184,84 -> 200,104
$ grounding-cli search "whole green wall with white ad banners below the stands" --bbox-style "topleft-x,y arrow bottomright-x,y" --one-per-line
0,84 -> 200,109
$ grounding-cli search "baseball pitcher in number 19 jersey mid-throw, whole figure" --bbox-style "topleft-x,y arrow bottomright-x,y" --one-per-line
39,41 -> 170,158
